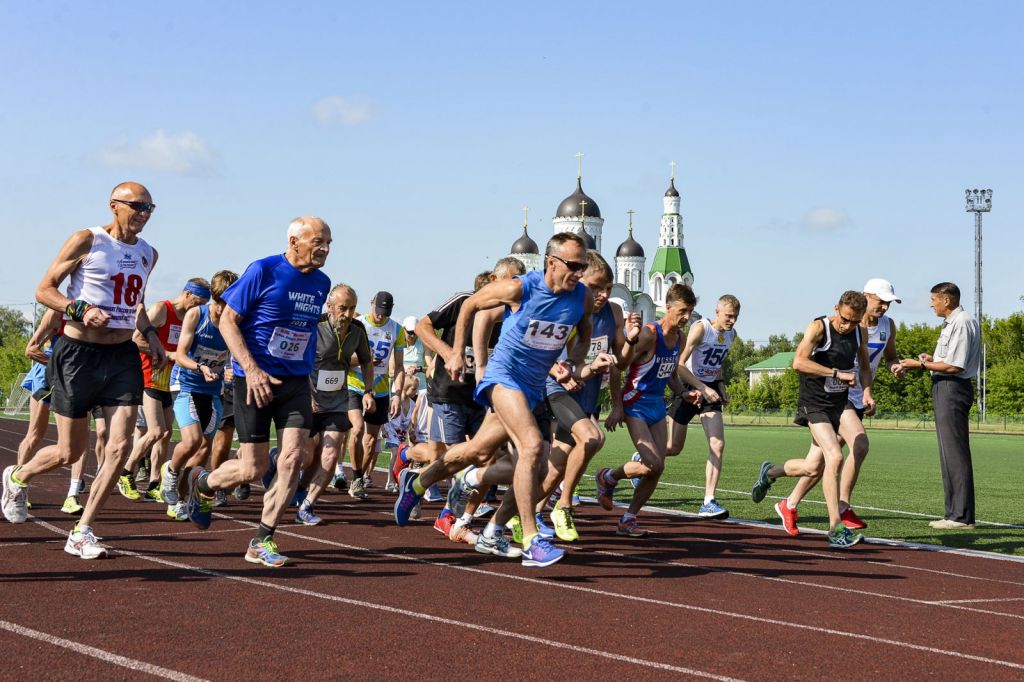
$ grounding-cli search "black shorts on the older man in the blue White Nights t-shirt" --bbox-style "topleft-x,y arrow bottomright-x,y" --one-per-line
234,375 -> 313,442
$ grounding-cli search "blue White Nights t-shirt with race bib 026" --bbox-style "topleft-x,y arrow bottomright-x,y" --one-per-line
223,254 -> 331,377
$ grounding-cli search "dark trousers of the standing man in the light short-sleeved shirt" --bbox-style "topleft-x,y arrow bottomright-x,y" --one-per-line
932,376 -> 974,523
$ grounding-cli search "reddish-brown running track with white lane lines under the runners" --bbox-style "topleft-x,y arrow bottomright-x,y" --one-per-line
0,420 -> 1024,681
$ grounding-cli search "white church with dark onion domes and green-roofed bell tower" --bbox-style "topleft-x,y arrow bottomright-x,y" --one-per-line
510,162 -> 693,323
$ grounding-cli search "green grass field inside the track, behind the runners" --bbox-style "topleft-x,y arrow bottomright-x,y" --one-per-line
581,424 -> 1024,555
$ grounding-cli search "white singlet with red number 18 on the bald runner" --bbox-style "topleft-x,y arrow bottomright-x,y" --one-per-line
65,227 -> 153,329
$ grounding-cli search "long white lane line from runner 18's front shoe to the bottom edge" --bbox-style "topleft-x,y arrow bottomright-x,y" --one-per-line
33,518 -> 740,682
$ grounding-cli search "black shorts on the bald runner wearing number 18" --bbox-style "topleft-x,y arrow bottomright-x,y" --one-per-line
46,335 -> 142,419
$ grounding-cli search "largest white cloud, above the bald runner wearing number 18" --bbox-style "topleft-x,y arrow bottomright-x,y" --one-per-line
99,129 -> 214,175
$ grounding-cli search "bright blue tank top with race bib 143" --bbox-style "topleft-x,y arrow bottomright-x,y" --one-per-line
476,270 -> 587,408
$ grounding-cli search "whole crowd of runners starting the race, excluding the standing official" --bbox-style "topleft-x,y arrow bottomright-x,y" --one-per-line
2,182 -> 923,566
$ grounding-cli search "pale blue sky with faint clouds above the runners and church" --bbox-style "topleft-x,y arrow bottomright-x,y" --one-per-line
0,2 -> 1024,342
